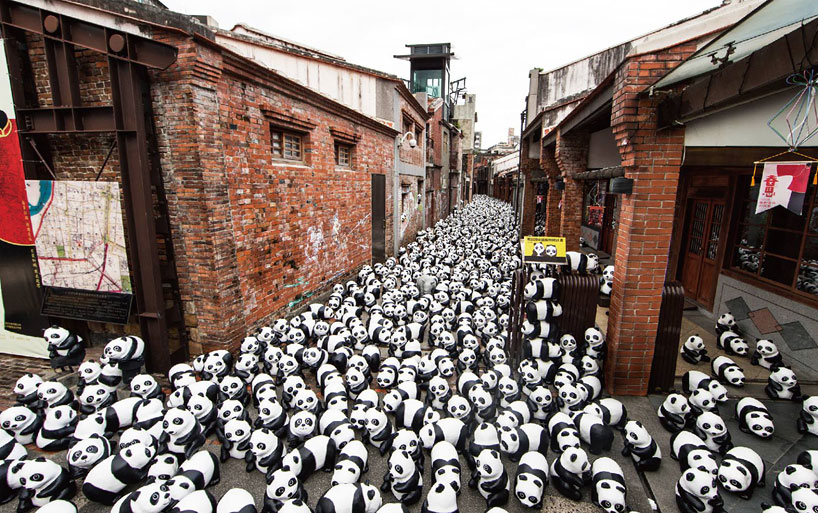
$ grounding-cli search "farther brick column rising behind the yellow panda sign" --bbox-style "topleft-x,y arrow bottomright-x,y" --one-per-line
554,130 -> 589,251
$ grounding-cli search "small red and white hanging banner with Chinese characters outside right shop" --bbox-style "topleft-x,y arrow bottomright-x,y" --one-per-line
756,162 -> 812,216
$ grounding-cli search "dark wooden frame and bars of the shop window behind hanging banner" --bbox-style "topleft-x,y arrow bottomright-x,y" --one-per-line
722,171 -> 818,305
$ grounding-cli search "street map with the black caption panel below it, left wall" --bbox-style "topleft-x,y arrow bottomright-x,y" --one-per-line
26,180 -> 132,324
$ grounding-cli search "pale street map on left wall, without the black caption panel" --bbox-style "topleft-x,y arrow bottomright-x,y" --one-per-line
26,180 -> 131,293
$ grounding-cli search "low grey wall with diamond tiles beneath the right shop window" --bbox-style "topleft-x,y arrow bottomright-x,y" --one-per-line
713,275 -> 818,381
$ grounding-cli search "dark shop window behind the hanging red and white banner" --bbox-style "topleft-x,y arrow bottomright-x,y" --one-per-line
729,176 -> 818,298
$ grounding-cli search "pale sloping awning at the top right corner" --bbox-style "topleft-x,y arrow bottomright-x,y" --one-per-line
654,0 -> 818,88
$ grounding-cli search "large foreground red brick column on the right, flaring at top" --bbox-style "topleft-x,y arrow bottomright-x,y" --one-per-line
605,44 -> 695,395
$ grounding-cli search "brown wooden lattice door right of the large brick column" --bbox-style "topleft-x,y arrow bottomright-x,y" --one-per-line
682,199 -> 724,308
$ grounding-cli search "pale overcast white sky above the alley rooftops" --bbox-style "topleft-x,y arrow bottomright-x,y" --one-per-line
162,0 -> 721,147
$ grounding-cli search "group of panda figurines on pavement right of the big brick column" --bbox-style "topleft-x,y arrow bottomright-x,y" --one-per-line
657,313 -> 818,513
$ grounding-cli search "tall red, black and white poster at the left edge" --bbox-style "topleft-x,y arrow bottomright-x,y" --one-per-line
0,40 -> 48,358
